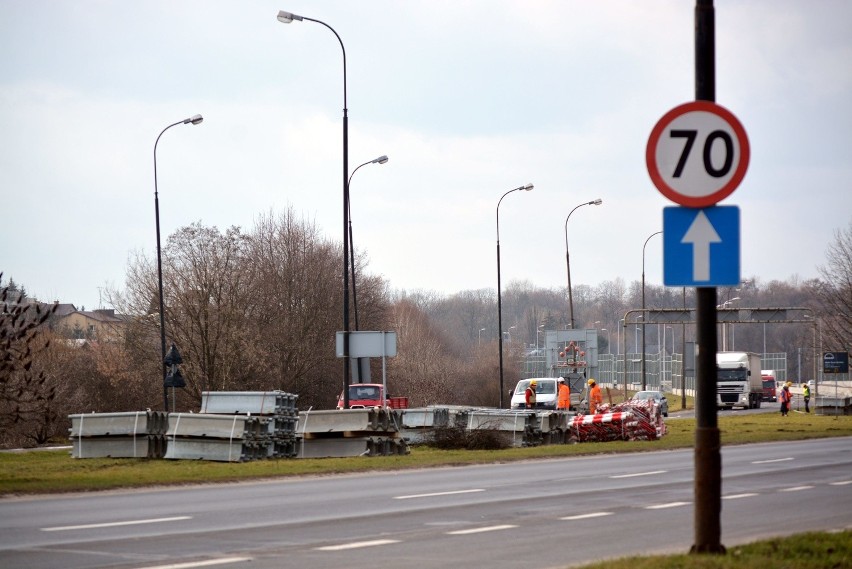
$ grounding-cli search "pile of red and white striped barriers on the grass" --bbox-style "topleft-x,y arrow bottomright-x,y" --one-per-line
569,400 -> 666,442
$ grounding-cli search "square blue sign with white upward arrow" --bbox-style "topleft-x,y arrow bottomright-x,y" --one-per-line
663,206 -> 740,287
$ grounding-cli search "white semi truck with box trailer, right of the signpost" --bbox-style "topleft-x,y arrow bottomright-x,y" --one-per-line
716,352 -> 763,409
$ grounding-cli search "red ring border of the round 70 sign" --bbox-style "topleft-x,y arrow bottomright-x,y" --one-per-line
645,101 -> 750,208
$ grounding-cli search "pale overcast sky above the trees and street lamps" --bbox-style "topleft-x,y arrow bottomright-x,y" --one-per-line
0,0 -> 852,309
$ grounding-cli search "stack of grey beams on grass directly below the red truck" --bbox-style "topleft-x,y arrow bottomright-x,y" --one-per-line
296,407 -> 409,458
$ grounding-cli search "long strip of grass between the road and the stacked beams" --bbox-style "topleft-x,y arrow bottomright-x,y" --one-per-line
0,413 -> 852,496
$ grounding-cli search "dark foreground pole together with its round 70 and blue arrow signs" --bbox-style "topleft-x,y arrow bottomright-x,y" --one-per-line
645,0 -> 749,553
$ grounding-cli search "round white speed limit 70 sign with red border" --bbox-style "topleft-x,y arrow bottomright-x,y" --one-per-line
645,101 -> 749,208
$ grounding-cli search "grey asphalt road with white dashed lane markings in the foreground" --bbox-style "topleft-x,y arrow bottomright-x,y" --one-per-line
0,437 -> 852,569
